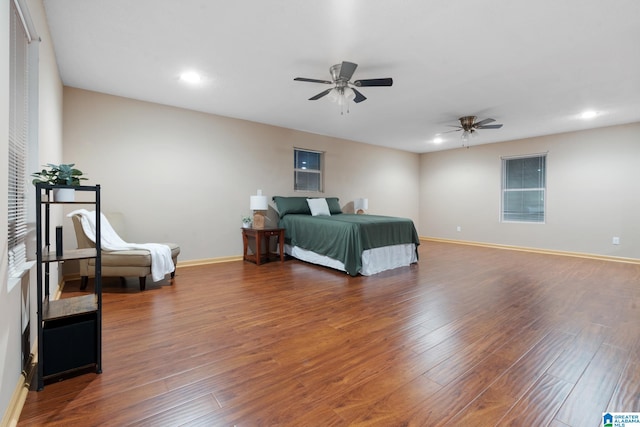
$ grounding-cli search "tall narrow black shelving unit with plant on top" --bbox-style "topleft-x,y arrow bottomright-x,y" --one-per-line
36,183 -> 102,390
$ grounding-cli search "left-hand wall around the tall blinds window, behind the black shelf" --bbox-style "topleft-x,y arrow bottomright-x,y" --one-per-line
0,0 -> 62,422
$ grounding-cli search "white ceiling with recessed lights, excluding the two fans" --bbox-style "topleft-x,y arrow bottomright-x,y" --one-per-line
44,0 -> 640,153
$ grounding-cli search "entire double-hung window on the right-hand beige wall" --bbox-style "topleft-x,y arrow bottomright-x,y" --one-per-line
502,154 -> 547,223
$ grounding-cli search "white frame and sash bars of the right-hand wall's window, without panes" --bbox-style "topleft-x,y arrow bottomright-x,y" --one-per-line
500,153 -> 547,224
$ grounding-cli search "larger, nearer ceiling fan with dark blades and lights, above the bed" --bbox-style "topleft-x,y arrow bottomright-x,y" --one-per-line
293,61 -> 393,113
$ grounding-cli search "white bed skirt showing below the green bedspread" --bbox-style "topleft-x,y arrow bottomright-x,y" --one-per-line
284,243 -> 418,276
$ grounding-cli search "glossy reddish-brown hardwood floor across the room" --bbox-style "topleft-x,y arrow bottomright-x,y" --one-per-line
19,242 -> 640,427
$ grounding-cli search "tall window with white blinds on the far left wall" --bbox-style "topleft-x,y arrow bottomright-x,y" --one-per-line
7,1 -> 29,277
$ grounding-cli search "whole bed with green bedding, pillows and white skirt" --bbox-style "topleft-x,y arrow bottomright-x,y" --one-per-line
273,196 -> 420,276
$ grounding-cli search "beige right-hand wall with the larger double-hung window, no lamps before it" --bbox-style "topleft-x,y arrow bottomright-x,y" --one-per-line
419,123 -> 640,258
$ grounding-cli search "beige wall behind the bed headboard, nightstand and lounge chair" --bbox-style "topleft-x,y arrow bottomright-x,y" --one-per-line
64,88 -> 419,261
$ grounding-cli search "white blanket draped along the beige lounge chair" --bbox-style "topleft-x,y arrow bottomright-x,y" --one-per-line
67,209 -> 175,282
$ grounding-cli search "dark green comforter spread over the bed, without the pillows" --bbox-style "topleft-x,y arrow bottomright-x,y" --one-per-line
278,214 -> 420,276
